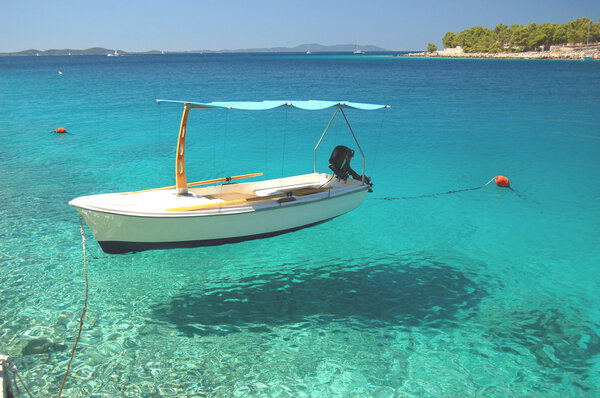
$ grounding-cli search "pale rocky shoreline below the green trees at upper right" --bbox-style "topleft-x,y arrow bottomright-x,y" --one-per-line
399,43 -> 600,60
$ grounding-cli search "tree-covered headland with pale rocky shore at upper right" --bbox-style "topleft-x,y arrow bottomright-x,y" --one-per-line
410,18 -> 600,59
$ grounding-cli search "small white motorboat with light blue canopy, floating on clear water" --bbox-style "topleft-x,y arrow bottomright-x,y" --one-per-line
69,100 -> 389,253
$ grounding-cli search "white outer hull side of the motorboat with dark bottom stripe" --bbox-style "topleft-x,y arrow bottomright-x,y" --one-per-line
77,188 -> 367,254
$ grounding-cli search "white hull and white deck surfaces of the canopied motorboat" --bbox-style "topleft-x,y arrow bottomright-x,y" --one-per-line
70,173 -> 369,253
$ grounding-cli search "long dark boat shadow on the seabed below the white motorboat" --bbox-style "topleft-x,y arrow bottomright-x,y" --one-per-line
151,256 -> 487,336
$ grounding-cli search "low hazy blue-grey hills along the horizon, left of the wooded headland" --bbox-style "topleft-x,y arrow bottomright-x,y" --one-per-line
0,43 -> 389,56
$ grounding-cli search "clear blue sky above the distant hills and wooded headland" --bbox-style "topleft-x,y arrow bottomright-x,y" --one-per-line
0,0 -> 600,52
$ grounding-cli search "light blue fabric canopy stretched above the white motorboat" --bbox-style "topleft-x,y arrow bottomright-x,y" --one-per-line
156,99 -> 390,111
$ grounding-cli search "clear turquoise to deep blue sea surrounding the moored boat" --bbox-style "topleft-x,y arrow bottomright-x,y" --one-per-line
0,54 -> 600,397
